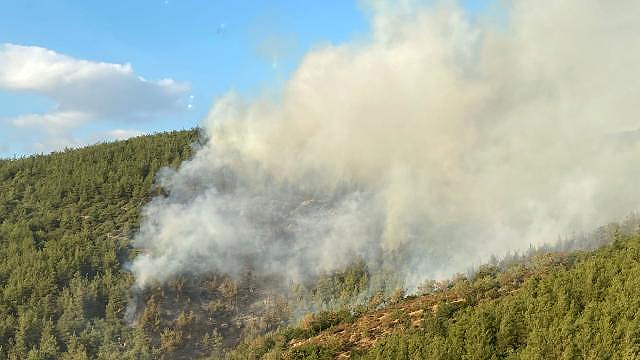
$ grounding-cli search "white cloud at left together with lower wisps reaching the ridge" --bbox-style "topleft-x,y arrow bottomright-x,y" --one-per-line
0,44 -> 189,151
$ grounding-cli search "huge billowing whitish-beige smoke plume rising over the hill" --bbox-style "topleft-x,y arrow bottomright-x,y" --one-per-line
131,0 -> 640,287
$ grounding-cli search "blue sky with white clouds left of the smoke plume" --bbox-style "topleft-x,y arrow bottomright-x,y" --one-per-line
0,0 -> 486,157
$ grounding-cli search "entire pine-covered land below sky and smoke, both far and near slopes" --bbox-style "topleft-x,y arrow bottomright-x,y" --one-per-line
0,130 -> 640,359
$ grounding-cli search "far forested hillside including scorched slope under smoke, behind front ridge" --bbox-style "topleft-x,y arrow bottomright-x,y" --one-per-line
0,130 -> 376,359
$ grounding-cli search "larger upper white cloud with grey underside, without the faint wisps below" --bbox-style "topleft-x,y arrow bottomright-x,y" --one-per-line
0,44 -> 189,116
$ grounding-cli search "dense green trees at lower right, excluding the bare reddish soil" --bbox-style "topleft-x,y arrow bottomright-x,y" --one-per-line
354,235 -> 640,359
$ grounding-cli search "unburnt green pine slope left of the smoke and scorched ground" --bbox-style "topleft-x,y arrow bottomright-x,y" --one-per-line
0,130 -> 197,359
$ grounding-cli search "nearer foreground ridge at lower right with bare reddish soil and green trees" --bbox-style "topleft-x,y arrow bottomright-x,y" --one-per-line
230,224 -> 640,360
